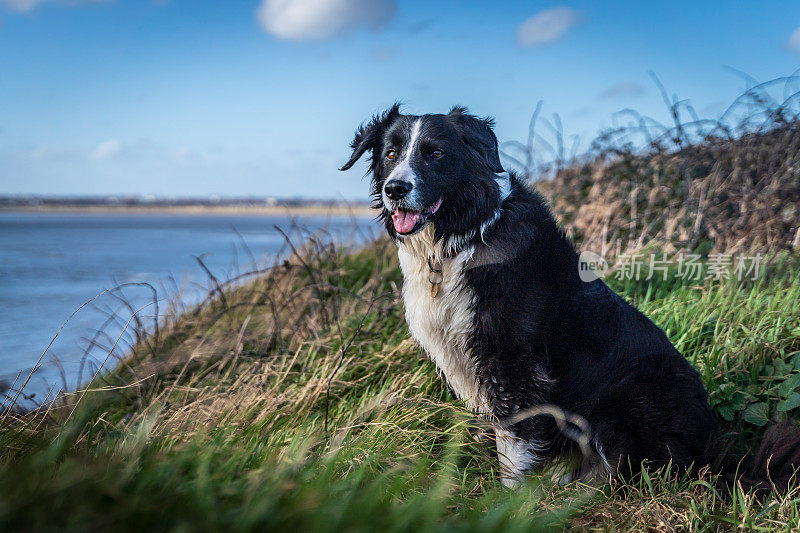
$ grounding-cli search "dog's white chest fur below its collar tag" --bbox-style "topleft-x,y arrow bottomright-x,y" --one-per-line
398,228 -> 489,413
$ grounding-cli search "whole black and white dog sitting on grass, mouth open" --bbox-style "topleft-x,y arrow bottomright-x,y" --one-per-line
342,105 -> 716,485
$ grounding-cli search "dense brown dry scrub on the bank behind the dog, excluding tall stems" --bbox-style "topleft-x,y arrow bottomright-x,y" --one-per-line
541,120 -> 800,254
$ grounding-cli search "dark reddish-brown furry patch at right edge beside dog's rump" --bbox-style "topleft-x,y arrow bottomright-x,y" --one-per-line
726,421 -> 800,493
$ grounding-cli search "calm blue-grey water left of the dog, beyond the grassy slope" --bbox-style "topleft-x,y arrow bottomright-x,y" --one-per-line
0,212 -> 376,405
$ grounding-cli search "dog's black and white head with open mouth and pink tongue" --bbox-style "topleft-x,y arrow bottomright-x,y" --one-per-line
341,104 -> 508,247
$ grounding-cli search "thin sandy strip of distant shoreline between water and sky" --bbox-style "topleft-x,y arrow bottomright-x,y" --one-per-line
0,204 -> 374,216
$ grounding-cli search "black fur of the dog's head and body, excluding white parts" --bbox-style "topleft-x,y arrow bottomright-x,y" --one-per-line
343,105 -> 800,486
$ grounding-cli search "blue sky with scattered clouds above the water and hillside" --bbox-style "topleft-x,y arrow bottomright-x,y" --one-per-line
0,0 -> 800,199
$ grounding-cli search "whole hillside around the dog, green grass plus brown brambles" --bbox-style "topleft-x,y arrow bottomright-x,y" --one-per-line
0,84 -> 800,531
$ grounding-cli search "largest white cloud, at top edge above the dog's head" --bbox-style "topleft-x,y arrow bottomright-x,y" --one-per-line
256,0 -> 395,41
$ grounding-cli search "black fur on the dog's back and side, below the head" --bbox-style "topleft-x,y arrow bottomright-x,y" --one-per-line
467,175 -> 715,473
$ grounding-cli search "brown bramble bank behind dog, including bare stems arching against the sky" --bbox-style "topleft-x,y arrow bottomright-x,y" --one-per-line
520,75 -> 800,256
